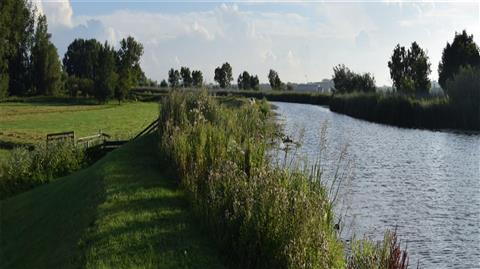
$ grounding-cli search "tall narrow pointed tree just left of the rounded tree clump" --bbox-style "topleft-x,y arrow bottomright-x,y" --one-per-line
31,15 -> 61,95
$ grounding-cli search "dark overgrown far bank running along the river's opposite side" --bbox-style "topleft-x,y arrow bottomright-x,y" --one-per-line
128,89 -> 480,131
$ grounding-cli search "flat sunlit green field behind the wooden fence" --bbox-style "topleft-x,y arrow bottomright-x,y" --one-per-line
0,100 -> 158,144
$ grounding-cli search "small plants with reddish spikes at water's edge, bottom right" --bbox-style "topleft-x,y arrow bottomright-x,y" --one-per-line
347,228 -> 408,269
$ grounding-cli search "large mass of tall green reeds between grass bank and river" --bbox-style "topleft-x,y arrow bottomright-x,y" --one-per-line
159,92 -> 343,268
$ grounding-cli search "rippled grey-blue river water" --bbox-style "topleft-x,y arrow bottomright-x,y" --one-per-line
272,102 -> 480,268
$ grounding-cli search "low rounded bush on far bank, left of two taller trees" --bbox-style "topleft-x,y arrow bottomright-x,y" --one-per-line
332,64 -> 376,93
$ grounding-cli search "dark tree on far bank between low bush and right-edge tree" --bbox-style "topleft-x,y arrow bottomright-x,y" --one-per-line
388,42 -> 431,95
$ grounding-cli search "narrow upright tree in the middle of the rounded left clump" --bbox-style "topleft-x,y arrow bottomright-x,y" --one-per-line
94,42 -> 118,103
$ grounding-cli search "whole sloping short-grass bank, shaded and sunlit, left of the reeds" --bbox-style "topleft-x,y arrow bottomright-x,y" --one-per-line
0,136 -> 222,268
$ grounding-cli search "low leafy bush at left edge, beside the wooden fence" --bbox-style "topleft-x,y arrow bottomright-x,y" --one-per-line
0,142 -> 85,199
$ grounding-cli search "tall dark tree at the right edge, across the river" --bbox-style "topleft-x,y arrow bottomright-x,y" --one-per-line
438,30 -> 480,89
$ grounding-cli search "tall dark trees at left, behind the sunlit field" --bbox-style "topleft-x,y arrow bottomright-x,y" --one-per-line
0,0 -> 149,102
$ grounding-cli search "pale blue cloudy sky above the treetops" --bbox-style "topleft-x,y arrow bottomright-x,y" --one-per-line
34,0 -> 480,86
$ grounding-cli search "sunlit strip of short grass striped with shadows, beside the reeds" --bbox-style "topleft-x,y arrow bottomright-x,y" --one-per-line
81,136 -> 223,268
